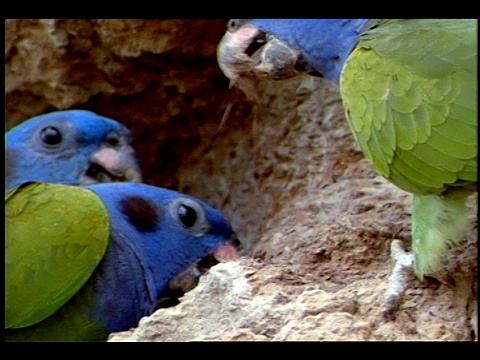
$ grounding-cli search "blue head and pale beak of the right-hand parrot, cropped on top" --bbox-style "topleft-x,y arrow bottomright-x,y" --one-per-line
217,19 -> 370,83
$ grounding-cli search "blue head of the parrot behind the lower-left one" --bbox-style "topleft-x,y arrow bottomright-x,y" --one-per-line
5,110 -> 141,188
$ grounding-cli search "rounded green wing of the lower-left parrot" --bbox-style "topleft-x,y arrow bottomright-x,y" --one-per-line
5,183 -> 109,328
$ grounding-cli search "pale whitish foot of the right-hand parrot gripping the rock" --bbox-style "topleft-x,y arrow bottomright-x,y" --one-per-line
383,240 -> 415,320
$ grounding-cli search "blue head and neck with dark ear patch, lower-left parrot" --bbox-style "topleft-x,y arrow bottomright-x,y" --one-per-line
86,183 -> 235,331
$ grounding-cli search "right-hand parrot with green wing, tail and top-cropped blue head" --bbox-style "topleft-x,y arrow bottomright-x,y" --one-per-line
217,19 -> 478,310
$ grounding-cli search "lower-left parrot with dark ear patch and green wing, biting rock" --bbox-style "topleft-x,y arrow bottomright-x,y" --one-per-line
5,182 -> 235,341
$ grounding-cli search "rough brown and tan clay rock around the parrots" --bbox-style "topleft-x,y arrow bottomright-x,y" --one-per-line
6,20 -> 478,341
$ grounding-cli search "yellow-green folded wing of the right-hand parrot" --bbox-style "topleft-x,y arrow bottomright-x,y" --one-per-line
340,19 -> 478,194
